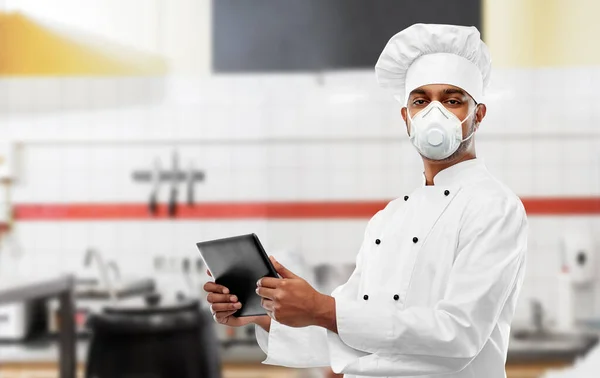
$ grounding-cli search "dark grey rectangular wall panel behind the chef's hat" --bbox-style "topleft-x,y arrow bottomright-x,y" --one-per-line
212,0 -> 481,72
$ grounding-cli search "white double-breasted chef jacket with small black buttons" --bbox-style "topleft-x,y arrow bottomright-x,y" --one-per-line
256,159 -> 527,378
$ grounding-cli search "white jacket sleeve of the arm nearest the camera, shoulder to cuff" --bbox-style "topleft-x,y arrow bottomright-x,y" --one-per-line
328,197 -> 527,376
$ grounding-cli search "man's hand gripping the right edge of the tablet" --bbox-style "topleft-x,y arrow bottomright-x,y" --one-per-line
256,256 -> 337,332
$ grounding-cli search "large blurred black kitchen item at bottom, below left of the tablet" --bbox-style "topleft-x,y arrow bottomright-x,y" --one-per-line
85,295 -> 221,378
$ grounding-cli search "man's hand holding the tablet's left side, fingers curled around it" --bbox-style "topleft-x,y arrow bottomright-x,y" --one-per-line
204,270 -> 270,328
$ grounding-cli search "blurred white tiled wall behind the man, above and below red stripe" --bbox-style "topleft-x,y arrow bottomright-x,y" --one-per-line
0,68 -> 600,320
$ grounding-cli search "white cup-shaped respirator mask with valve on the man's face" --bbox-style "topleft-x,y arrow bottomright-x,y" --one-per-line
407,101 -> 477,160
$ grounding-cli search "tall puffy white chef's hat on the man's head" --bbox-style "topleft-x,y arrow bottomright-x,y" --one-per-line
375,24 -> 491,105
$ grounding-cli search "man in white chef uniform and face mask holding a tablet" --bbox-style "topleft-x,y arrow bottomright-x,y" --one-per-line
205,24 -> 527,378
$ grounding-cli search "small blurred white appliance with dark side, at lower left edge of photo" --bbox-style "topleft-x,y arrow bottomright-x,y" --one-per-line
0,299 -> 46,341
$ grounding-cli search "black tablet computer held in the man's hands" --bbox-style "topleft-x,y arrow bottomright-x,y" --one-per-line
196,234 -> 278,317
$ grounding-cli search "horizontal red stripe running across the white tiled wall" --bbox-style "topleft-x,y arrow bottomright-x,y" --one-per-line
14,197 -> 600,221
